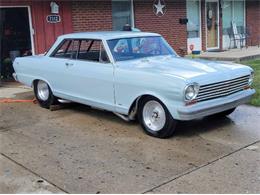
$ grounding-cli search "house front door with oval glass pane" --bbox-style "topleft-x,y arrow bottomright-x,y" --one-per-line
206,0 -> 219,50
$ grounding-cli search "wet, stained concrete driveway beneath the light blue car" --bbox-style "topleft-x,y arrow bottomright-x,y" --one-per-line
0,85 -> 260,193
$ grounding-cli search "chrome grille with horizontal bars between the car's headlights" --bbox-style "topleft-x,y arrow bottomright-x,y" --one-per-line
196,75 -> 250,102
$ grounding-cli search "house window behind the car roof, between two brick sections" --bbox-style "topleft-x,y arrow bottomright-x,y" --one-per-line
112,0 -> 133,30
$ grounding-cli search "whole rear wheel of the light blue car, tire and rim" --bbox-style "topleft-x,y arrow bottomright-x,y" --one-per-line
33,80 -> 57,108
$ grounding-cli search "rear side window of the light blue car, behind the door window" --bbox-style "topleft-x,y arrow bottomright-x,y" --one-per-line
52,40 -> 80,59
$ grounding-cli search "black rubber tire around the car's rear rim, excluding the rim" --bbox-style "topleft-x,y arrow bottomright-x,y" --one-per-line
33,80 -> 58,109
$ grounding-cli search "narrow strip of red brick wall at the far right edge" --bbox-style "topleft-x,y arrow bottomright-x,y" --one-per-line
246,0 -> 260,45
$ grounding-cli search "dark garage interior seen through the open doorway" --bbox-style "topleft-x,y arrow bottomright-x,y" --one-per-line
0,7 -> 32,81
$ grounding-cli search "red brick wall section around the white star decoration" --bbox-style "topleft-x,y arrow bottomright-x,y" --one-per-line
134,0 -> 187,55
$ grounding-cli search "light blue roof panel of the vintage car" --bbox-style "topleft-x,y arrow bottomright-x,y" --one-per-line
59,31 -> 161,40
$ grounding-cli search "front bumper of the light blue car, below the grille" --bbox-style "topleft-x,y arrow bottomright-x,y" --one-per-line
178,89 -> 255,120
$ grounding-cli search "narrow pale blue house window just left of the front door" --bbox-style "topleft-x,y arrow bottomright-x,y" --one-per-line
186,0 -> 200,38
